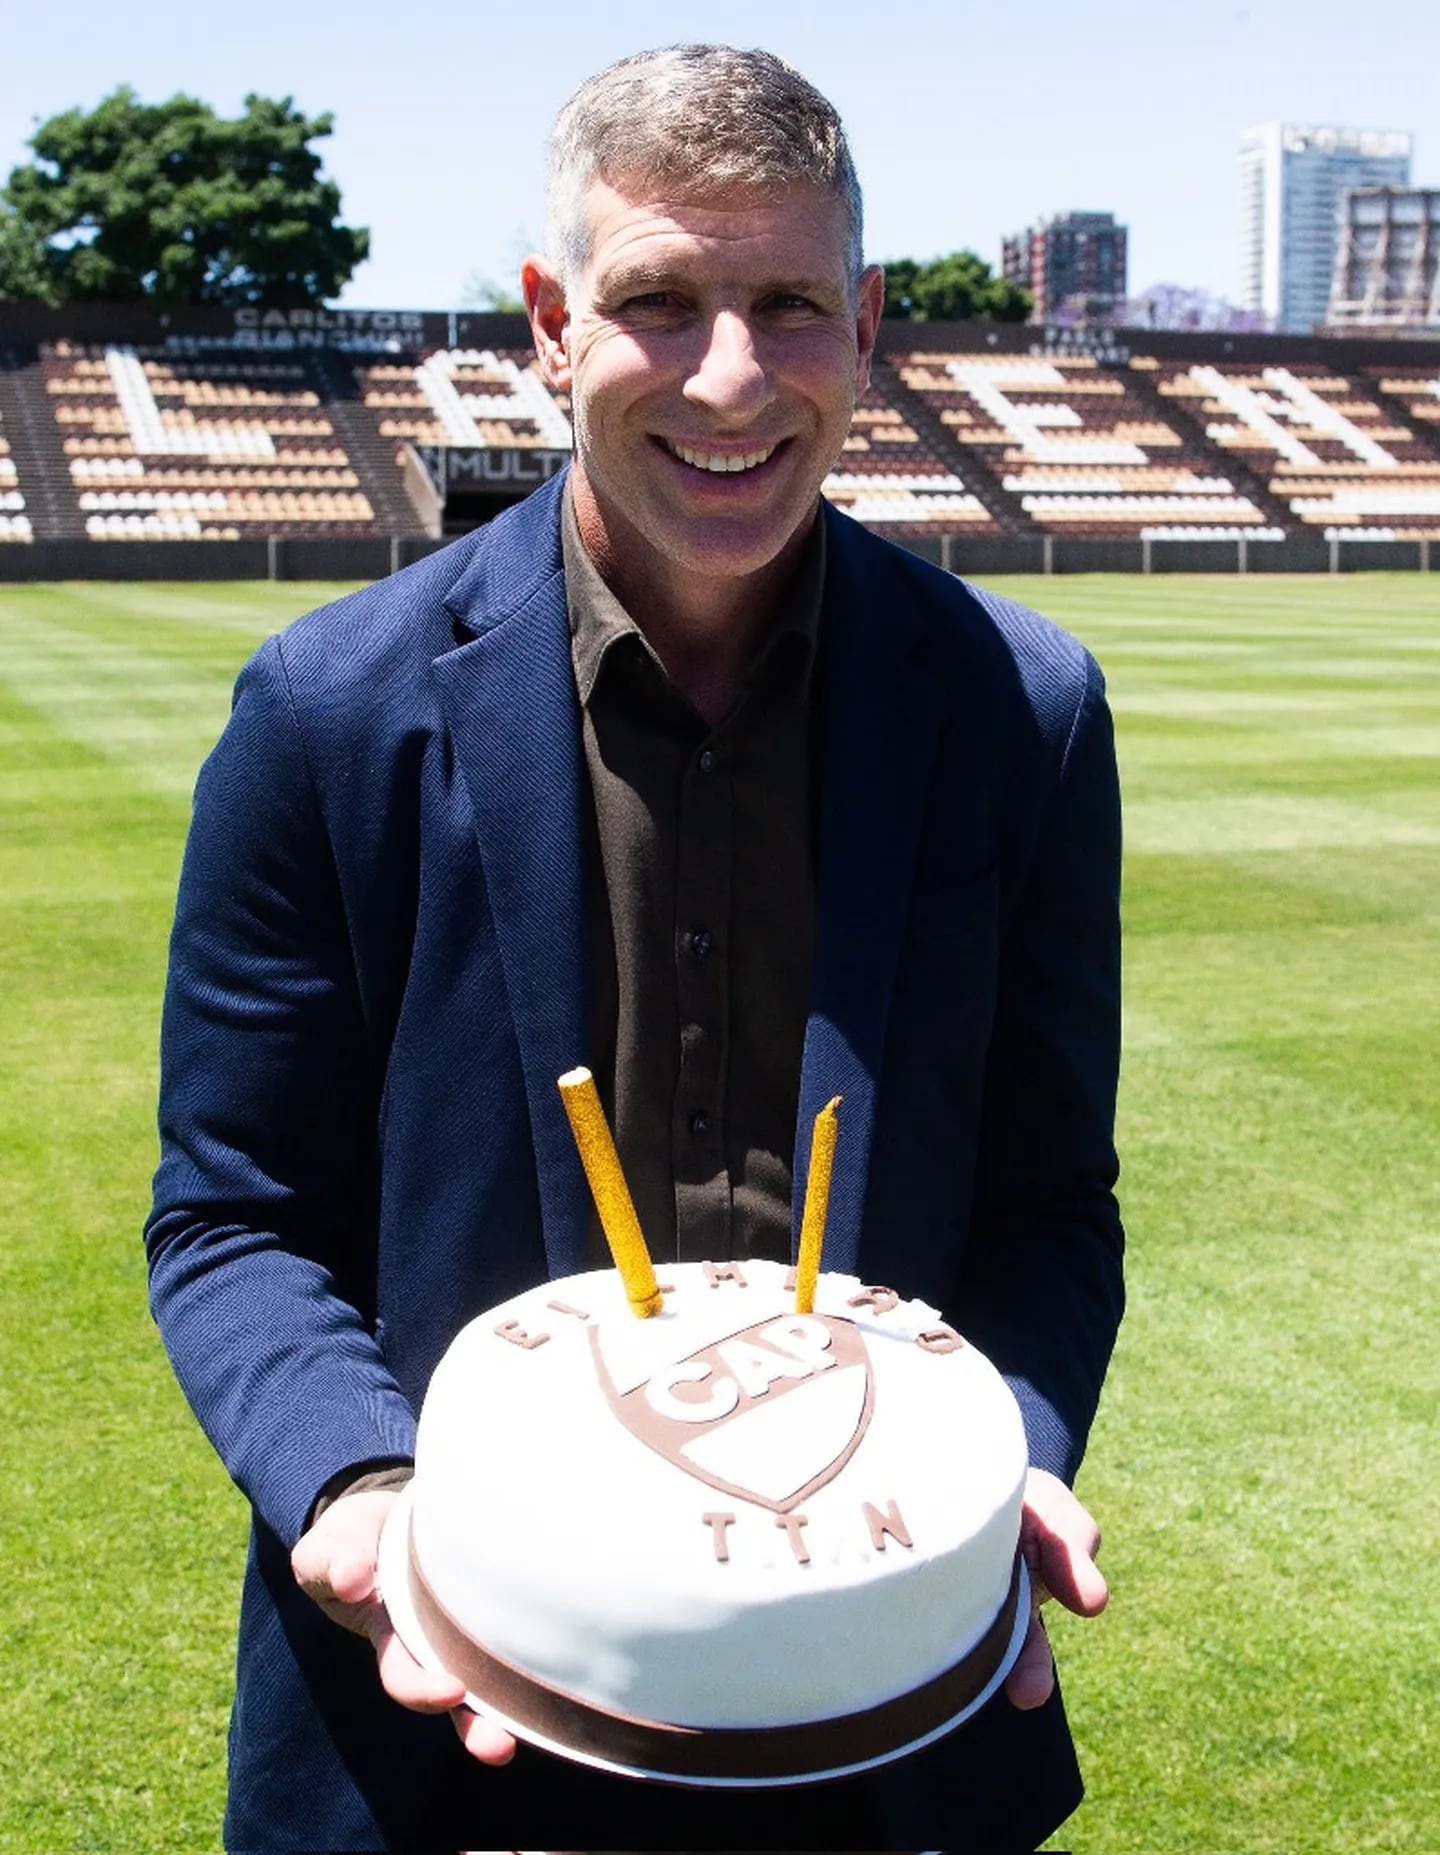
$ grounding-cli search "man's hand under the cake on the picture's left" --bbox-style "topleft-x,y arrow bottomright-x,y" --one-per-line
289,1488 -> 516,1764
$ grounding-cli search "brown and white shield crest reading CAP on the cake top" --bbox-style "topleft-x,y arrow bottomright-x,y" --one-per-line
590,1306 -> 874,1514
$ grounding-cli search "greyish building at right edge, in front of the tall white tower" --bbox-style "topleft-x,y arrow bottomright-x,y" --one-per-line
1331,187 -> 1440,332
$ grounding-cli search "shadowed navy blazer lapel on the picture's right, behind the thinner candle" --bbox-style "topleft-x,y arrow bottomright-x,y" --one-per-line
792,508 -> 941,1274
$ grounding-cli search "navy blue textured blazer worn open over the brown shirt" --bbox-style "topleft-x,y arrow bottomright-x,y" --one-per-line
147,480 -> 1123,1849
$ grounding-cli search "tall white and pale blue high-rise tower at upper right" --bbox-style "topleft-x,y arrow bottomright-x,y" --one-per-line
1240,122 -> 1410,332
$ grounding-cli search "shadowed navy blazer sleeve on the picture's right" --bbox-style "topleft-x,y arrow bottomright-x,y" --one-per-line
956,657 -> 1125,1480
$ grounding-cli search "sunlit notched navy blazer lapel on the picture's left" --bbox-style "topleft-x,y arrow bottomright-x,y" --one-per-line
434,482 -> 590,1276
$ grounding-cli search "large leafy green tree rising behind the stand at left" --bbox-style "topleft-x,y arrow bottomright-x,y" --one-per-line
0,87 -> 369,306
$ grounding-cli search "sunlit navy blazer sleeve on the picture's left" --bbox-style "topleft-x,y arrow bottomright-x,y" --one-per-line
145,638 -> 414,1543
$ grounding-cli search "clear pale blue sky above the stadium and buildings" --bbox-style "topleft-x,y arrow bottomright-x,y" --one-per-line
0,0 -> 1440,310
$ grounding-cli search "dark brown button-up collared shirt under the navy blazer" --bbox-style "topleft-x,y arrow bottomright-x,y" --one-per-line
562,497 -> 824,1267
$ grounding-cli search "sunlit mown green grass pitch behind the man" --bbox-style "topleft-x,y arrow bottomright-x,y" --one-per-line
0,575 -> 1440,1855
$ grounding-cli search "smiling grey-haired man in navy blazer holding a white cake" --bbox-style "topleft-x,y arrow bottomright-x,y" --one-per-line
147,46 -> 1121,1849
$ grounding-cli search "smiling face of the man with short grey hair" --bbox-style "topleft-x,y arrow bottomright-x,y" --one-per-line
525,182 -> 883,586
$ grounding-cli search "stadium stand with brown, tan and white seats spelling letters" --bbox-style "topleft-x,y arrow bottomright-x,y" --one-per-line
0,304 -> 1440,571
